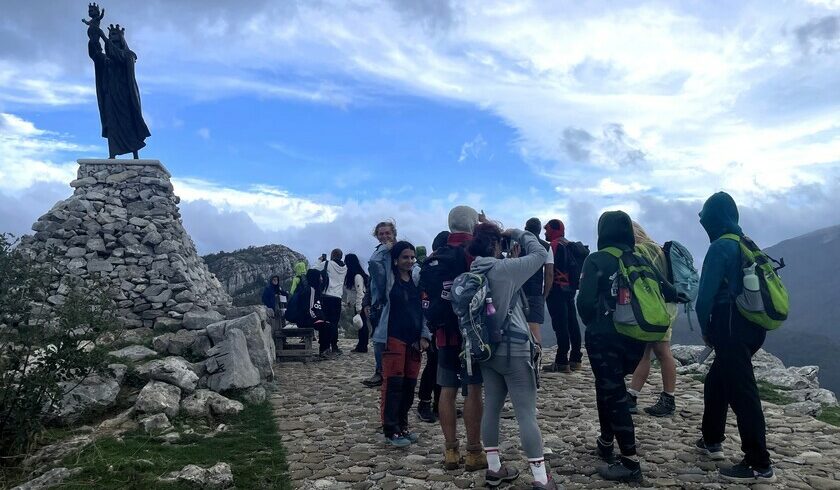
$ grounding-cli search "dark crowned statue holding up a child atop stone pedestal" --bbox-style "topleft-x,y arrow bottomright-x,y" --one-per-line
82,3 -> 151,159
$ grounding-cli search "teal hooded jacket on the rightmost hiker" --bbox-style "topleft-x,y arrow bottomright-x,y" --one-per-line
695,192 -> 744,335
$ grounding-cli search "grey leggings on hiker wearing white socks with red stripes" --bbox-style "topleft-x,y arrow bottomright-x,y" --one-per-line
480,355 -> 543,459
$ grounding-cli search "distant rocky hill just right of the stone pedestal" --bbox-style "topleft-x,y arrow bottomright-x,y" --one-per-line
203,245 -> 306,306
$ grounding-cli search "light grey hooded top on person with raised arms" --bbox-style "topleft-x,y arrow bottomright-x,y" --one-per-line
470,230 -> 548,357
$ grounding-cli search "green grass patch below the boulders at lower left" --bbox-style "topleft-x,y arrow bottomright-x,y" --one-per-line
53,402 -> 291,490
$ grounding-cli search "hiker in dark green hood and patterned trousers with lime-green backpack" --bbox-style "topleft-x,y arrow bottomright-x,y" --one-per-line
577,211 -> 687,482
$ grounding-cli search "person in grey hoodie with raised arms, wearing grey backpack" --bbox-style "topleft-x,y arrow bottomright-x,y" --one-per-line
452,222 -> 557,489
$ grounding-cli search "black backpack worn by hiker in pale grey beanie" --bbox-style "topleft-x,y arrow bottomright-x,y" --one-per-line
420,245 -> 468,331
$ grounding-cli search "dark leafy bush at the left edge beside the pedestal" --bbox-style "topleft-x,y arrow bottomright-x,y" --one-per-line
0,234 -> 116,463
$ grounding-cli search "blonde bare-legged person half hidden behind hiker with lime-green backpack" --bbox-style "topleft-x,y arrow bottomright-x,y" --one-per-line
627,221 -> 677,417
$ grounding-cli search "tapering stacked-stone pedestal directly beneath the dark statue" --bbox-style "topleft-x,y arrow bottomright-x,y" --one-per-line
21,160 -> 230,331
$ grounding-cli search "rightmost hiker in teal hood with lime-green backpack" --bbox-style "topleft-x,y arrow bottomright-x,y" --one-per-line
696,192 -> 788,483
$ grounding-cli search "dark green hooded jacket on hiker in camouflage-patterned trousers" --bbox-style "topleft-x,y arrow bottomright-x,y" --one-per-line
577,211 -> 677,334
